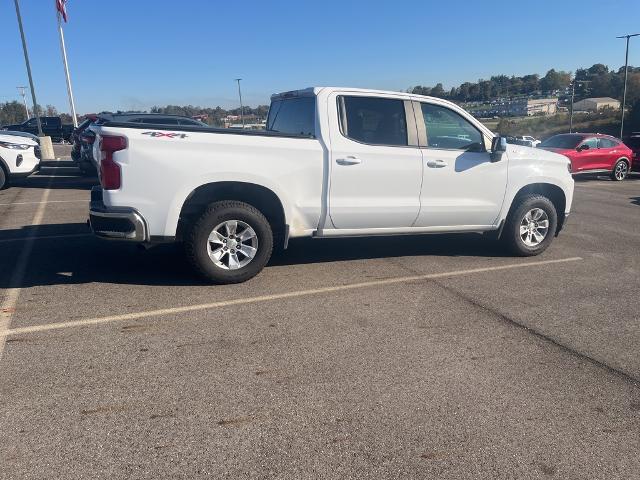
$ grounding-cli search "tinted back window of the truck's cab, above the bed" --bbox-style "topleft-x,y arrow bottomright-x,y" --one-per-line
267,97 -> 316,137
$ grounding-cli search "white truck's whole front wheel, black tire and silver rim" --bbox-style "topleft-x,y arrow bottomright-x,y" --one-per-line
502,195 -> 558,257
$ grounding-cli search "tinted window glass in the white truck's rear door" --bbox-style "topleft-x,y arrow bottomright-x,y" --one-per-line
338,97 -> 409,147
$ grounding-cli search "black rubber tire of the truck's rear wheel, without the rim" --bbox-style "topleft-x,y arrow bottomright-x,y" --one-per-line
184,200 -> 273,284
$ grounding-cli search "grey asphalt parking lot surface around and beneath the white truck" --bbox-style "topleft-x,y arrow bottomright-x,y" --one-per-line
0,147 -> 640,479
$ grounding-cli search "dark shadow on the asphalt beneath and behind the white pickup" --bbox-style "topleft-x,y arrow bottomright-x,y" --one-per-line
0,223 -> 505,288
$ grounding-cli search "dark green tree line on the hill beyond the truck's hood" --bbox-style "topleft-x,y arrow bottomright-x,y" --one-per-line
408,63 -> 640,104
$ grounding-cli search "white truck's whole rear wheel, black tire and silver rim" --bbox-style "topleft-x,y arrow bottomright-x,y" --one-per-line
184,200 -> 273,284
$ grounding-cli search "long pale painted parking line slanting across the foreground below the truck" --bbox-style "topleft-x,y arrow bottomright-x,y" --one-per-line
0,257 -> 582,343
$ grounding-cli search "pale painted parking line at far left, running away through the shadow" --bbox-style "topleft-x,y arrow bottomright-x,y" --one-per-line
0,185 -> 51,360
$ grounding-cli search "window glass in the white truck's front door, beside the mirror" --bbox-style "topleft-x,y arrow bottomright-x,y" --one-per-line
421,103 -> 485,152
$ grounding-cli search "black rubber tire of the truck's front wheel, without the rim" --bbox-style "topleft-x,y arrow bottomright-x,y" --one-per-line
502,194 -> 558,257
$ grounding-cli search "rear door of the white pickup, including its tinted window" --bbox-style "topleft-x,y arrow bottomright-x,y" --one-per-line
328,93 -> 422,229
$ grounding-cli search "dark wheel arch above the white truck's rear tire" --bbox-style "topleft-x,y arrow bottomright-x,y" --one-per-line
176,181 -> 289,248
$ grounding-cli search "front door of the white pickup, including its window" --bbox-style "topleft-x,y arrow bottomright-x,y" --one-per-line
414,103 -> 509,227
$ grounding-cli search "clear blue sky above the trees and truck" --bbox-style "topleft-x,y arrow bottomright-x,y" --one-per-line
0,0 -> 640,113
